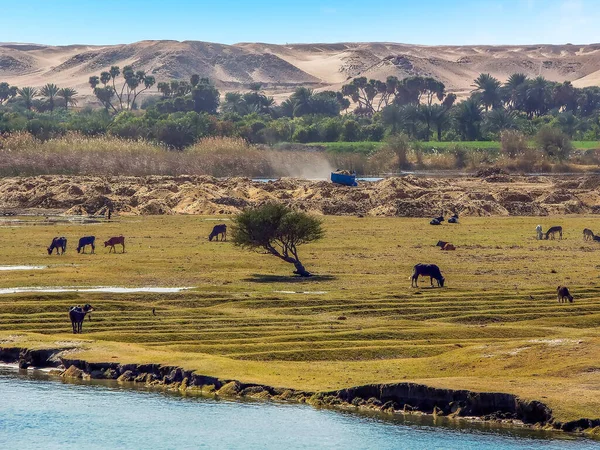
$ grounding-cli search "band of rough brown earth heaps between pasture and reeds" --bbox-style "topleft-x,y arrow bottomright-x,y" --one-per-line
0,174 -> 600,217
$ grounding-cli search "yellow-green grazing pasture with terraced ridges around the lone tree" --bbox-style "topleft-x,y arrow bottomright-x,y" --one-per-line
0,216 -> 600,420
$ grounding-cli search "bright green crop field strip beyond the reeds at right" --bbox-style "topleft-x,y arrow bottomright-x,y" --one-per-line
306,141 -> 600,154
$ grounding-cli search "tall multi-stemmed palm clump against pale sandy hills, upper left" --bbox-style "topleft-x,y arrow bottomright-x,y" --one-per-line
88,66 -> 156,112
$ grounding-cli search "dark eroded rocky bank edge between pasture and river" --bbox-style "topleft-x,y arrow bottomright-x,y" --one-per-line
0,347 -> 600,433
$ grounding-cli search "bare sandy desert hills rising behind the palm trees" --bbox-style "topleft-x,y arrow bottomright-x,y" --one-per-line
0,41 -> 600,101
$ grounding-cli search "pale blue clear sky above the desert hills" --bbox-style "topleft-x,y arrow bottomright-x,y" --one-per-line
0,0 -> 600,45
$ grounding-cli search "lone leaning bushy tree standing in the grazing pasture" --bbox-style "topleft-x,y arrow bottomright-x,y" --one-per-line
232,203 -> 324,277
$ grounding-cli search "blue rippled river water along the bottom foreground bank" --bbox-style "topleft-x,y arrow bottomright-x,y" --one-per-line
0,368 -> 600,450
